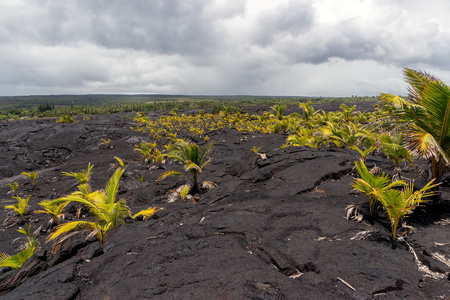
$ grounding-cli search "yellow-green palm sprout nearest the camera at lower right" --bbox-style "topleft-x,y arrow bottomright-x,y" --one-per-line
374,180 -> 436,240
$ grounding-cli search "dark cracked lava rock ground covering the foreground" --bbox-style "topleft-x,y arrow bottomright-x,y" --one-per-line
0,103 -> 450,299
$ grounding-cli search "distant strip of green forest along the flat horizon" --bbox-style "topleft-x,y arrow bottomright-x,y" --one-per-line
0,94 -> 377,120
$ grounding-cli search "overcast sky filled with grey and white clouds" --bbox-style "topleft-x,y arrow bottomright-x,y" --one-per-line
0,0 -> 450,96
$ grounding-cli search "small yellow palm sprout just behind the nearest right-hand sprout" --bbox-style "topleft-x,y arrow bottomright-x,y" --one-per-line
352,161 -> 406,213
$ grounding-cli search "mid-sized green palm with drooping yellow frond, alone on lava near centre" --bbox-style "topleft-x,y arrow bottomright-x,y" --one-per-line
158,140 -> 213,194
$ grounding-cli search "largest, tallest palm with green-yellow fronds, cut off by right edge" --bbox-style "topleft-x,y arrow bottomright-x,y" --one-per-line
382,68 -> 450,181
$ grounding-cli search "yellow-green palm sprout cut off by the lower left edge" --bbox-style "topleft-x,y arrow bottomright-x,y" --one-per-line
0,224 -> 39,270
